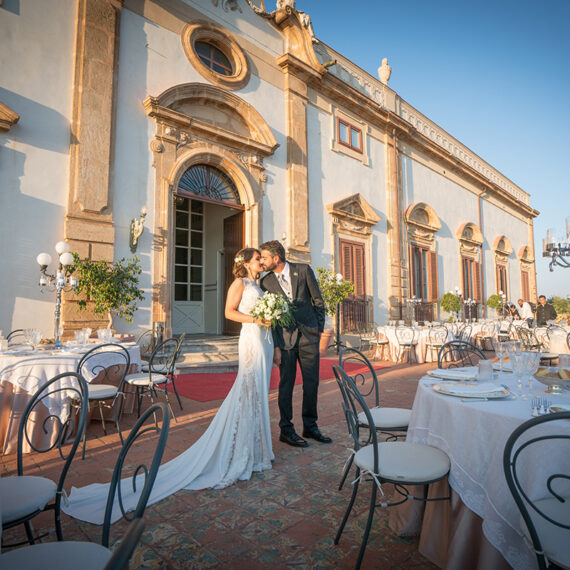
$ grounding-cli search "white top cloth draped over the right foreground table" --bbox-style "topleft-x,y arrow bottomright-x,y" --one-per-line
407,373 -> 570,570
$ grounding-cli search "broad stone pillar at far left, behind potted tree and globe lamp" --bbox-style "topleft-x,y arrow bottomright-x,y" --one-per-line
62,0 -> 122,329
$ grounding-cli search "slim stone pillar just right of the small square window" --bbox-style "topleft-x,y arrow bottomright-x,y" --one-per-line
385,127 -> 402,319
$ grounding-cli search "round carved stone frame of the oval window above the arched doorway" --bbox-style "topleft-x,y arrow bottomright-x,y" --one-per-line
181,20 -> 246,91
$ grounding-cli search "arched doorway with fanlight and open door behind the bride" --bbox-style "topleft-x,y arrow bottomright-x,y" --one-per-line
172,164 -> 244,334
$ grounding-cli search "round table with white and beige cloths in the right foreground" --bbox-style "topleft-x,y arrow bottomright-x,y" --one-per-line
390,366 -> 570,570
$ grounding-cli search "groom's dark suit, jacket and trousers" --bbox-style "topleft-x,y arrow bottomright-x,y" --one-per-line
261,263 -> 325,435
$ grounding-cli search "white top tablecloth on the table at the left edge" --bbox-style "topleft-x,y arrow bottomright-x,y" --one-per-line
0,344 -> 141,415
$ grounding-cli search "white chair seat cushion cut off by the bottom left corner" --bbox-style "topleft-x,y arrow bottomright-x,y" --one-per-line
2,540 -> 112,570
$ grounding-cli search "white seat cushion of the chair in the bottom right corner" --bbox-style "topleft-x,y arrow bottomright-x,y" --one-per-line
520,497 -> 570,568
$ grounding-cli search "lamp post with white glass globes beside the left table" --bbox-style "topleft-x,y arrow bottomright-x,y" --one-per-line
36,241 -> 78,349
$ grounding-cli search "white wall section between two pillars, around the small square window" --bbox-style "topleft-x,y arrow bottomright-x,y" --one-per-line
307,105 -> 388,322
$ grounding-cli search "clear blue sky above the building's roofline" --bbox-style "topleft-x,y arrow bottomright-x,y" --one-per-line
292,0 -> 570,296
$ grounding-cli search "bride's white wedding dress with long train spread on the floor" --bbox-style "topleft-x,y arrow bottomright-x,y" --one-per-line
62,279 -> 274,524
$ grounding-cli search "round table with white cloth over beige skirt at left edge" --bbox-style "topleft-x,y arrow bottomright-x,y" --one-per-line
0,343 -> 141,454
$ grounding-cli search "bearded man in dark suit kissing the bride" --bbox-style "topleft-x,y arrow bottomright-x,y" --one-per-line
260,240 -> 332,447
